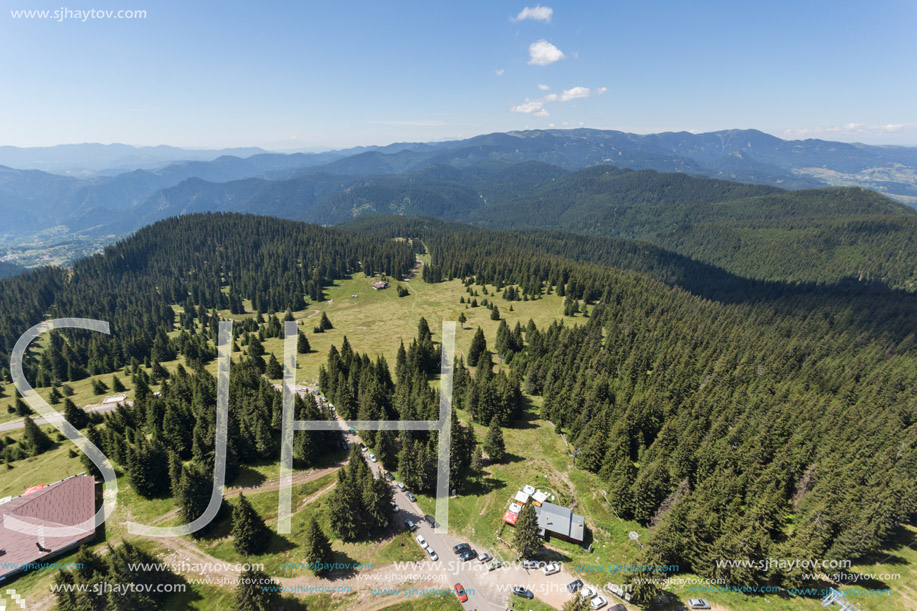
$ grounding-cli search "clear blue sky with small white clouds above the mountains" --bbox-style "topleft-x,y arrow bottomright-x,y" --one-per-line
0,0 -> 917,150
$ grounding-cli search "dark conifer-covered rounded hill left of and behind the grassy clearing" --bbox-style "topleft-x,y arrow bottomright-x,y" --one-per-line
0,213 -> 414,380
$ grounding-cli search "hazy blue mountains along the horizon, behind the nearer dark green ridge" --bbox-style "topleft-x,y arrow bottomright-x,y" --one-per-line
0,129 -> 917,250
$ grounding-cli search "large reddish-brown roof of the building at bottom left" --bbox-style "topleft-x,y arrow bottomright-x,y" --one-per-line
0,475 -> 96,580
